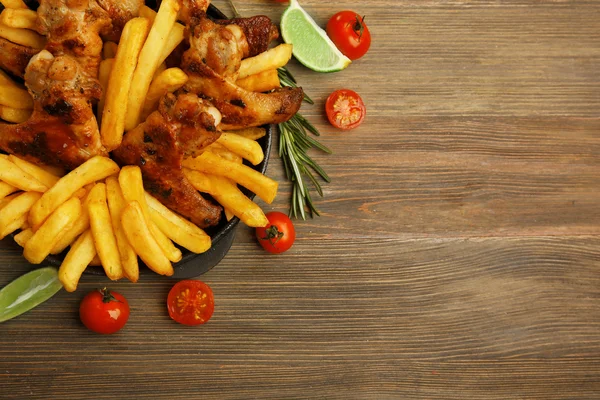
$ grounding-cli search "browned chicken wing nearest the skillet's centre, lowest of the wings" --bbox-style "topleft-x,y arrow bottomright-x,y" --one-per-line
112,94 -> 222,228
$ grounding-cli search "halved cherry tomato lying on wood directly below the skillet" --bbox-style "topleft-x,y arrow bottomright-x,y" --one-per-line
167,279 -> 215,326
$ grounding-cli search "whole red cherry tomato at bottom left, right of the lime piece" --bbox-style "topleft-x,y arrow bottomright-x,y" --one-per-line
79,288 -> 129,334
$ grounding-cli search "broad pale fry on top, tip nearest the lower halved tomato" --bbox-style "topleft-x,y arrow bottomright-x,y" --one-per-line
121,201 -> 174,276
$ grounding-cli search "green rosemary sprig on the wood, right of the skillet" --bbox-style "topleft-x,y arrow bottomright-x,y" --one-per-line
277,67 -> 331,219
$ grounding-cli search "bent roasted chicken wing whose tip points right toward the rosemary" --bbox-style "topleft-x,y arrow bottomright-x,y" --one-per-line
181,17 -> 303,130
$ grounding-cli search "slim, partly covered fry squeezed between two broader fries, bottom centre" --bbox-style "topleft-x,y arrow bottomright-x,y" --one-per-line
106,176 -> 140,282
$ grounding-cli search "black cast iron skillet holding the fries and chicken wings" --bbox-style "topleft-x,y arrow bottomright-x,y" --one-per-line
7,1 -> 276,279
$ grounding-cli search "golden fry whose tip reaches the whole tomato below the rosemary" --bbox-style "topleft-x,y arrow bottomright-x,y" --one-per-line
184,169 -> 269,228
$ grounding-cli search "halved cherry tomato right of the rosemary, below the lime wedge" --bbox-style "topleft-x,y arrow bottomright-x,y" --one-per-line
325,89 -> 367,130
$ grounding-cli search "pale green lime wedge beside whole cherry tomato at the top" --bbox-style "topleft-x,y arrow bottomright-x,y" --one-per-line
281,0 -> 352,72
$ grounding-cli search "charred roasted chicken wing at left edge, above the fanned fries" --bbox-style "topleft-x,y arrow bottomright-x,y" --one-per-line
0,50 -> 106,169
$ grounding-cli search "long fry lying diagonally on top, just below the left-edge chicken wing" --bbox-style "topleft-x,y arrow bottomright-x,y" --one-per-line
29,156 -> 119,230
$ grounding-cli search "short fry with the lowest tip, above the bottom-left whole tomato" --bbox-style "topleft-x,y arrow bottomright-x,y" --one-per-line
58,230 -> 96,292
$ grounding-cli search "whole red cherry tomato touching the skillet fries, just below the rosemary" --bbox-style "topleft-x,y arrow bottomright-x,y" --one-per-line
256,211 -> 296,253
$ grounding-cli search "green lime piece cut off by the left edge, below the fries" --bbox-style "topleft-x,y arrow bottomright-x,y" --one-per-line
0,267 -> 62,322
